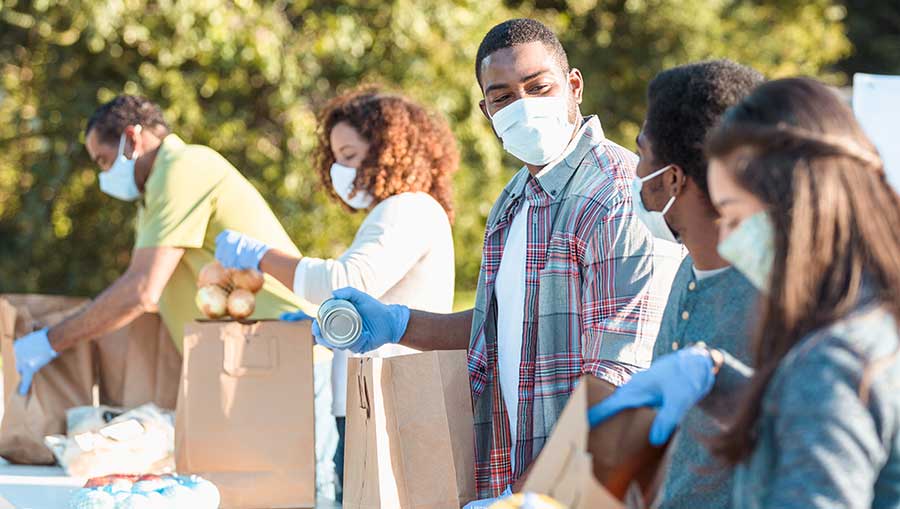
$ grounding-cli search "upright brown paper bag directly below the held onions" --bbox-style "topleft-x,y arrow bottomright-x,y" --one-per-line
175,321 -> 316,509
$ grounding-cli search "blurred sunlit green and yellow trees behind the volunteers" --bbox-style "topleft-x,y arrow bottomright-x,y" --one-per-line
0,0 -> 872,304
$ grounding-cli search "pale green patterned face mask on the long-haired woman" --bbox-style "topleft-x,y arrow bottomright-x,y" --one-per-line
718,212 -> 775,292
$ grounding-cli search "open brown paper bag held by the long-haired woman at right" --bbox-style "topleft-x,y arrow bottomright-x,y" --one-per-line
522,376 -> 665,509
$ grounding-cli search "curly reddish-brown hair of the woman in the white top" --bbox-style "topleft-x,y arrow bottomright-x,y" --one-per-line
316,87 -> 459,222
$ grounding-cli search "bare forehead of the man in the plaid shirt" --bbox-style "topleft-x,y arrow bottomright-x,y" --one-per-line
481,42 -> 562,90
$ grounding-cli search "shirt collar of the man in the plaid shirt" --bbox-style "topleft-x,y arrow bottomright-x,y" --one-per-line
510,115 -> 606,200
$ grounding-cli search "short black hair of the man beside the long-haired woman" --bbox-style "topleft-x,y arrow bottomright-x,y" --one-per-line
644,59 -> 765,196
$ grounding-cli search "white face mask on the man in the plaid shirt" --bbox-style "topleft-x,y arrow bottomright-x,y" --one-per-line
491,97 -> 575,166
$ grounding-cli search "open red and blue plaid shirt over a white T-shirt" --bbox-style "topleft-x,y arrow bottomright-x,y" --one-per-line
468,117 -> 667,498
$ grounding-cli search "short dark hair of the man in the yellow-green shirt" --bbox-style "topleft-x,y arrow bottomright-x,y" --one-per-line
84,95 -> 169,143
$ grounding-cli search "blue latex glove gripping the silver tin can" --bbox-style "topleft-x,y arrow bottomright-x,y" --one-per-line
312,288 -> 409,353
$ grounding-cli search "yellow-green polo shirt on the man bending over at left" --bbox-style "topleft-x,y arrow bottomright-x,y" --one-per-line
135,134 -> 321,357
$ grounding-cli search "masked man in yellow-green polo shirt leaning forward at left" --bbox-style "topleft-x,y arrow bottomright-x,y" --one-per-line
15,95 -> 333,496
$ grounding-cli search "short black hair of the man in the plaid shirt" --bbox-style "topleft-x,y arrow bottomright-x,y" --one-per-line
475,18 -> 569,85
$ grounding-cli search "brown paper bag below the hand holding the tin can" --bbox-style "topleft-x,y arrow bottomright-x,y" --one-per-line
344,350 -> 475,509
